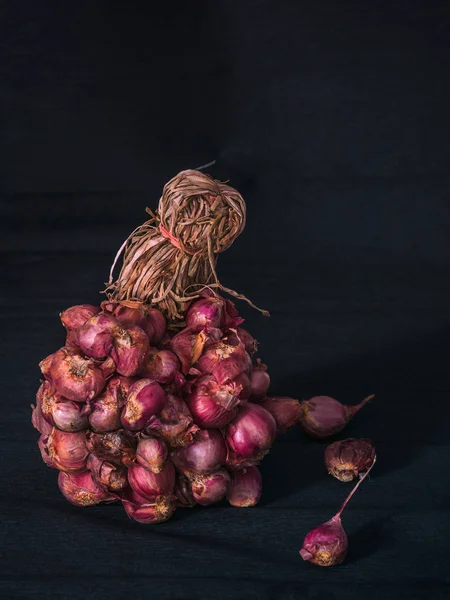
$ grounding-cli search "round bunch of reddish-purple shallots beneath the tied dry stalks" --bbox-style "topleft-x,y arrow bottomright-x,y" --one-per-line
32,291 -> 301,523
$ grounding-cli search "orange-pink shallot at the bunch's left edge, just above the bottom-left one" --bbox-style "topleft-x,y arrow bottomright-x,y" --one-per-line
46,427 -> 89,473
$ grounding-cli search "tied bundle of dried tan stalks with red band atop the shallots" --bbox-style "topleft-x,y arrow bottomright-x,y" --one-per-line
105,170 -> 268,322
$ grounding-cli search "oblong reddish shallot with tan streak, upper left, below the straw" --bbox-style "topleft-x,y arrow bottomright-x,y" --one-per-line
111,325 -> 150,377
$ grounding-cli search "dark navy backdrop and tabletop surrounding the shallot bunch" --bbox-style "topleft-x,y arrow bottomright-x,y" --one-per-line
0,0 -> 450,600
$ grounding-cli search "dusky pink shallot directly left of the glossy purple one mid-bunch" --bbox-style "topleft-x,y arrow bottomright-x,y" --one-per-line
89,375 -> 134,433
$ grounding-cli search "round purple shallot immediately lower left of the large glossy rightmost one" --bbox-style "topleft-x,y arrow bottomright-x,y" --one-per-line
171,429 -> 227,475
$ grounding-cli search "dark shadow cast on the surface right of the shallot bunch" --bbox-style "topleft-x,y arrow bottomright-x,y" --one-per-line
270,327 -> 449,496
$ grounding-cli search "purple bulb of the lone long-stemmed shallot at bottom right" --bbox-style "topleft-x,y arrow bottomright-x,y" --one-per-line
300,516 -> 348,567
